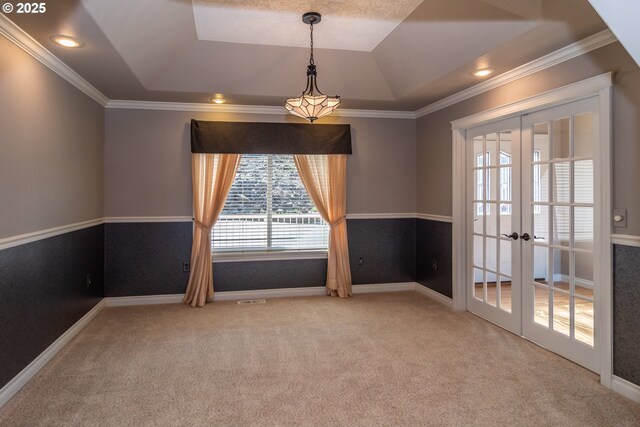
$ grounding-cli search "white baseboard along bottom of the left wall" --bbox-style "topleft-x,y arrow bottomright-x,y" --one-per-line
0,300 -> 105,408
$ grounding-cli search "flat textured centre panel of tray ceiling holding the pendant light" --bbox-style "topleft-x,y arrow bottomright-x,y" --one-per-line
193,0 -> 422,52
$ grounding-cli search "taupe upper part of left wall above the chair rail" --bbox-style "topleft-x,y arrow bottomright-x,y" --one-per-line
0,37 -> 104,238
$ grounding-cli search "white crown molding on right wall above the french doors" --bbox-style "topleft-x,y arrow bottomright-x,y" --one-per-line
415,29 -> 618,118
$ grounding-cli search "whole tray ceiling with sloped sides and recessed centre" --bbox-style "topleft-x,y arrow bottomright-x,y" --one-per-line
5,0 -> 606,111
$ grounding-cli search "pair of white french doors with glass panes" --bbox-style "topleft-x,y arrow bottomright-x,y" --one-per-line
466,97 -> 599,371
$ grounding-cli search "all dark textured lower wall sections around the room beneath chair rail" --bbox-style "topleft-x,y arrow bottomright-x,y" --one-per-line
0,224 -> 640,394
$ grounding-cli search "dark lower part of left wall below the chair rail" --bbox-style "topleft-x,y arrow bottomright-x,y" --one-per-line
0,225 -> 104,392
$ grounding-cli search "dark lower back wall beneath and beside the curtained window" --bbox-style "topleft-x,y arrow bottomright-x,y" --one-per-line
105,218 -> 416,297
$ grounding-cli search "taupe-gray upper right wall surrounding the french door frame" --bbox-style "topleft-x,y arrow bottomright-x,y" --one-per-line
416,43 -> 640,235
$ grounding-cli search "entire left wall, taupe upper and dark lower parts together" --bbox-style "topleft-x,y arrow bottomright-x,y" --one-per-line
0,37 -> 104,388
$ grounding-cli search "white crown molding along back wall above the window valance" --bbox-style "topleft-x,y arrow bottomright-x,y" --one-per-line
106,100 -> 416,119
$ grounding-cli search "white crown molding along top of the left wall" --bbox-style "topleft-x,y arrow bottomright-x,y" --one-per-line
0,13 -> 109,107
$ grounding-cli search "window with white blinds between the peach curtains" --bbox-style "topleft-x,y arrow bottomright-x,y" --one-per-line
211,154 -> 329,252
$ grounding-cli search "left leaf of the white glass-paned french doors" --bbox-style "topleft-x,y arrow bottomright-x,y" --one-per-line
467,117 -> 522,334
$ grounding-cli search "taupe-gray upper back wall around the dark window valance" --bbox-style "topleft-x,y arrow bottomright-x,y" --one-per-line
105,109 -> 416,217
